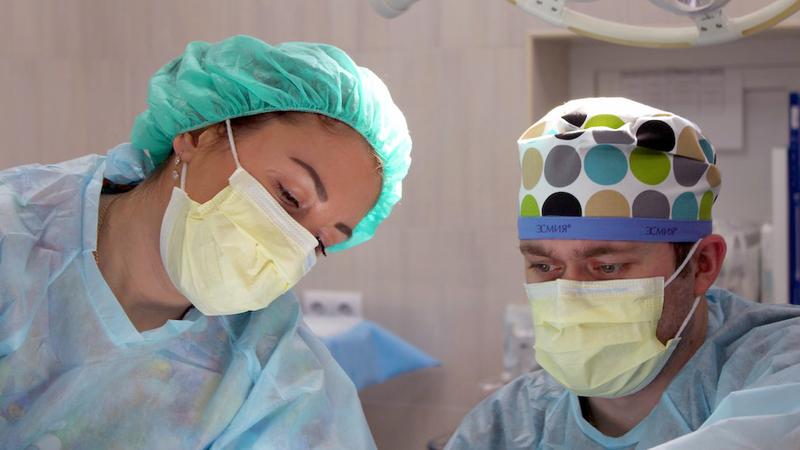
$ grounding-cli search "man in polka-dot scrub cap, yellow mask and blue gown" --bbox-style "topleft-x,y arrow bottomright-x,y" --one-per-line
447,98 -> 800,450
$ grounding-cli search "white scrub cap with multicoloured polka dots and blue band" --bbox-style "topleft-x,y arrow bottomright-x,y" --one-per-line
518,98 -> 722,242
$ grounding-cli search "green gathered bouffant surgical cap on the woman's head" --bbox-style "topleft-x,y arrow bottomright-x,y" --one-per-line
131,36 -> 411,251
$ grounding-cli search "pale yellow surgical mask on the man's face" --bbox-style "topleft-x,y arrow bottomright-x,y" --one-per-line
525,243 -> 700,398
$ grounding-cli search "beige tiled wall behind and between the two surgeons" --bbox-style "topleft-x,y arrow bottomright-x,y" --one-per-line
0,0 -> 796,450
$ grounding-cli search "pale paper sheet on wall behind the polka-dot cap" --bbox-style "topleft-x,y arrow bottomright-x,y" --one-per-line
597,68 -> 744,151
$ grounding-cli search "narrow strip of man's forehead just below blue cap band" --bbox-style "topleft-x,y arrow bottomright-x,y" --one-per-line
519,239 -> 665,256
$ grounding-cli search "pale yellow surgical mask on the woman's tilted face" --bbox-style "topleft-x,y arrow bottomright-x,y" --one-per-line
161,121 -> 317,316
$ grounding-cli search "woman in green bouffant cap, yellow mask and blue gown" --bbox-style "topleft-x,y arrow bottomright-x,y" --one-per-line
0,36 -> 411,449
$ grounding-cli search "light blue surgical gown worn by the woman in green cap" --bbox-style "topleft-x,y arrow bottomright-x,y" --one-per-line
0,145 -> 375,450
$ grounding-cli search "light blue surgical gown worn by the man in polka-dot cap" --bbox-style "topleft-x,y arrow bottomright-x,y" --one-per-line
446,288 -> 800,450
